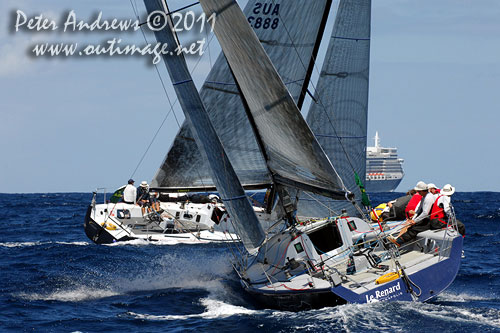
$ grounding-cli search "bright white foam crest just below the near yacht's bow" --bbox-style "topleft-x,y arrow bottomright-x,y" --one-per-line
127,298 -> 265,320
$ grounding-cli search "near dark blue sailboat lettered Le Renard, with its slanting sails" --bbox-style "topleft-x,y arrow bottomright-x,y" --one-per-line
145,0 -> 462,310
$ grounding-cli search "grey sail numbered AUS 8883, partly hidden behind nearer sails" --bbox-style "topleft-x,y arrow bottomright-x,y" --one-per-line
152,0 -> 331,189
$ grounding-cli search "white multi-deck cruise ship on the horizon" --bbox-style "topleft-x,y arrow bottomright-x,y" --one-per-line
365,132 -> 404,193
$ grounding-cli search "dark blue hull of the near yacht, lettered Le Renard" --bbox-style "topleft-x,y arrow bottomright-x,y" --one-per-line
242,228 -> 463,311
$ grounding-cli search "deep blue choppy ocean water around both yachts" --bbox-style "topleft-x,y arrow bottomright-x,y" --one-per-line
0,192 -> 500,332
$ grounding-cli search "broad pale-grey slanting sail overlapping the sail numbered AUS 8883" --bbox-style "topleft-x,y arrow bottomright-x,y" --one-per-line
200,0 -> 345,199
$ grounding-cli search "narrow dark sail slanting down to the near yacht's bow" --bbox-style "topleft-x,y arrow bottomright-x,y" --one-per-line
144,0 -> 264,251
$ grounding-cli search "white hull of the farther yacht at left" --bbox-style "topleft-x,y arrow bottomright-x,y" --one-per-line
85,197 -> 239,244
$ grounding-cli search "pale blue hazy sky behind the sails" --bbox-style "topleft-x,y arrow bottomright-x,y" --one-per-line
0,0 -> 500,193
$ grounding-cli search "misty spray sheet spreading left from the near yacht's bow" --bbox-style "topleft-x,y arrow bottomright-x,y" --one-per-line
12,252 -> 232,304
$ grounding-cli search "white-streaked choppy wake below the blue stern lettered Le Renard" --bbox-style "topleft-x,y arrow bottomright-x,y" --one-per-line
271,294 -> 500,332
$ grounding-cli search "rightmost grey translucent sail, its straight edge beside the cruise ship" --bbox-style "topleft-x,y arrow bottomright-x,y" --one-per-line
299,0 -> 371,216
